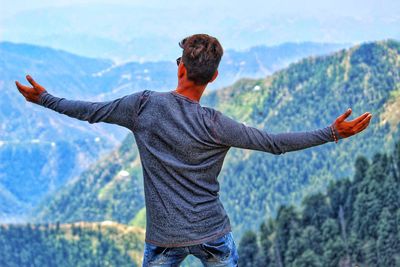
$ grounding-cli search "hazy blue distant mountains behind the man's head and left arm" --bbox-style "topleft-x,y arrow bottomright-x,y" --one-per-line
0,42 -> 346,222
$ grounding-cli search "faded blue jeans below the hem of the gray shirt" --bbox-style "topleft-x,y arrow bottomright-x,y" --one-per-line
142,232 -> 239,267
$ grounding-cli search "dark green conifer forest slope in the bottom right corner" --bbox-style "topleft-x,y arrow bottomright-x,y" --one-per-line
239,138 -> 400,267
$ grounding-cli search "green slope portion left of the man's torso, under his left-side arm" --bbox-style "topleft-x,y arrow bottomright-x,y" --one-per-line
33,134 -> 144,223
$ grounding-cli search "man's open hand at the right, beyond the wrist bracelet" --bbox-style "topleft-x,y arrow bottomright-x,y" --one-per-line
334,108 -> 372,138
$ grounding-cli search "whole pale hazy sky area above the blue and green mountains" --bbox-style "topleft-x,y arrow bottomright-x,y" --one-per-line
0,0 -> 400,60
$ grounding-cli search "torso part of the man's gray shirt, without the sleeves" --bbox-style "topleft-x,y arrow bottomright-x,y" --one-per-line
133,91 -> 231,247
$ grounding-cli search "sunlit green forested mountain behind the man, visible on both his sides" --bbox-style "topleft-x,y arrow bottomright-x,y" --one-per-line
36,38 -> 400,245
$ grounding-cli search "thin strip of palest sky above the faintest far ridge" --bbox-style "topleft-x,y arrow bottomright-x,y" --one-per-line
0,0 -> 400,20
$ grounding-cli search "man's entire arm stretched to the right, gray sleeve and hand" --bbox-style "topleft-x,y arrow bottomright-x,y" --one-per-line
210,109 -> 372,154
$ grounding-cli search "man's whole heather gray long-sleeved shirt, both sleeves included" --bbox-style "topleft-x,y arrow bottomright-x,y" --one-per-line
39,90 -> 334,247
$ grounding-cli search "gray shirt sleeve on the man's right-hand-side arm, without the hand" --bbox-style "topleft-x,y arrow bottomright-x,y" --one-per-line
211,111 -> 334,154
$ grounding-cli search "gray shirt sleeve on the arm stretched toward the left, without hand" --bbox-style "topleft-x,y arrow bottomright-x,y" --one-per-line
38,91 -> 144,130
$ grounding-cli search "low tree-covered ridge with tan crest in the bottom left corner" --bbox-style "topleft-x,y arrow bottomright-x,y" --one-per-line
0,222 -> 144,267
